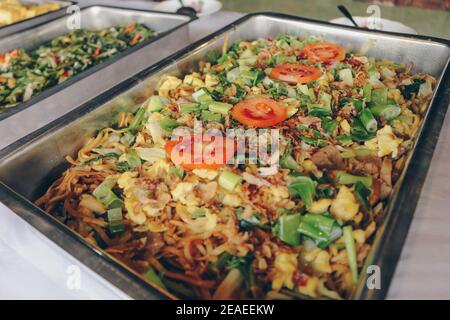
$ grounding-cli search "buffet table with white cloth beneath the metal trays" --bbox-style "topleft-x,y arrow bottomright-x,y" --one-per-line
0,1 -> 450,299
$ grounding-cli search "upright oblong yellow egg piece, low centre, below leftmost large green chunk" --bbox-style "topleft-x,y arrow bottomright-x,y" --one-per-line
272,252 -> 298,291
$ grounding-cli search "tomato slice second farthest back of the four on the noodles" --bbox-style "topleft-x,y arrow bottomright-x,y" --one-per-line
269,63 -> 322,83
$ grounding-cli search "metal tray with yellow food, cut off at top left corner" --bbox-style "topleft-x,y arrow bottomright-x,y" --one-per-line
0,0 -> 76,37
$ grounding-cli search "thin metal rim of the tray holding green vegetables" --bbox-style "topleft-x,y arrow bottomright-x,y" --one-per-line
0,4 -> 197,121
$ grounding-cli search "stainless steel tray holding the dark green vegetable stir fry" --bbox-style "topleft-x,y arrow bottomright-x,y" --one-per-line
0,5 -> 192,121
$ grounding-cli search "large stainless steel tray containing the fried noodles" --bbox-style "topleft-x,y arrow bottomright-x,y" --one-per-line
0,13 -> 450,299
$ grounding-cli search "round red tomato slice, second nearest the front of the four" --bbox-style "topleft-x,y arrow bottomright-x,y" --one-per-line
231,97 -> 287,128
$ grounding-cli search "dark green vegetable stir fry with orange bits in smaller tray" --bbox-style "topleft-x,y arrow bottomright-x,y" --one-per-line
0,24 -> 155,112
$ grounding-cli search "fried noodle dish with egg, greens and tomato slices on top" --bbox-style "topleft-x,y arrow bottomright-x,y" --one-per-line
36,34 -> 436,299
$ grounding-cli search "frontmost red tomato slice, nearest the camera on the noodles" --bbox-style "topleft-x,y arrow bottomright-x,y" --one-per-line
165,134 -> 236,171
